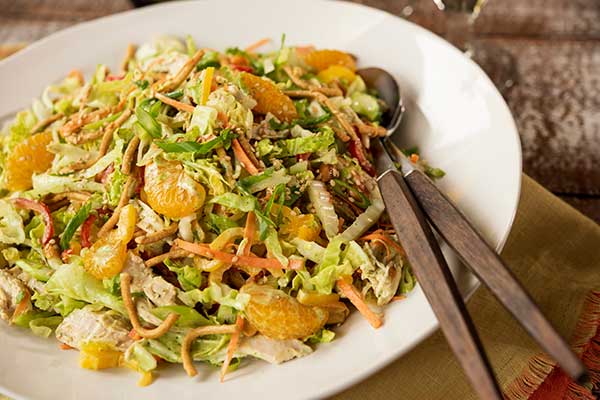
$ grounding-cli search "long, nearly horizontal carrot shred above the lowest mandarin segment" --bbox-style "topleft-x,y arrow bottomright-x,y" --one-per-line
175,239 -> 302,270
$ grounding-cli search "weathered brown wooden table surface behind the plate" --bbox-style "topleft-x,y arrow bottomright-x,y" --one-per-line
0,0 -> 600,222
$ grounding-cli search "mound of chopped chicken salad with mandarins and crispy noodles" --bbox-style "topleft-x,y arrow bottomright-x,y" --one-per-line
0,37 -> 443,386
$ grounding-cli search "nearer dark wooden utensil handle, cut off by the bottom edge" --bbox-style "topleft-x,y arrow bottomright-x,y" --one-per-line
378,170 -> 502,400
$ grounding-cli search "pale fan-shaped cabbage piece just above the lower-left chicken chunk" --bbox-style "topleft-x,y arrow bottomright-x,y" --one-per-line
46,263 -> 126,314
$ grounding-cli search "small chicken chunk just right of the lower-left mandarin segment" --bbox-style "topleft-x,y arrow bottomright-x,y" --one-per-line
123,251 -> 177,306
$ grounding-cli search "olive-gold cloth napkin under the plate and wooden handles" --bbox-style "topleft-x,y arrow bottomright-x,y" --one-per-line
334,175 -> 600,400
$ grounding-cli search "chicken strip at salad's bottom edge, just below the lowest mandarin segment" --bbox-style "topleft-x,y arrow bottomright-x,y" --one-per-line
237,335 -> 313,364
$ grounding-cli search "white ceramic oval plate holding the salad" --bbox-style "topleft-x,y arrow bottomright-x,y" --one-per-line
0,0 -> 521,400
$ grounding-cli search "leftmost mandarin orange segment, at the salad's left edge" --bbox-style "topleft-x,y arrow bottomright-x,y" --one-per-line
4,132 -> 54,192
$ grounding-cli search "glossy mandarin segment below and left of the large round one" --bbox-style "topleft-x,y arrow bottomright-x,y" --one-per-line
83,230 -> 127,279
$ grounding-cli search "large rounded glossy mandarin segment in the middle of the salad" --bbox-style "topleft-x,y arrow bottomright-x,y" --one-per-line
144,161 -> 206,218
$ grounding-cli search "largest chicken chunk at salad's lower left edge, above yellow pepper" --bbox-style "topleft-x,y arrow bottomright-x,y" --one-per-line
56,309 -> 133,351
